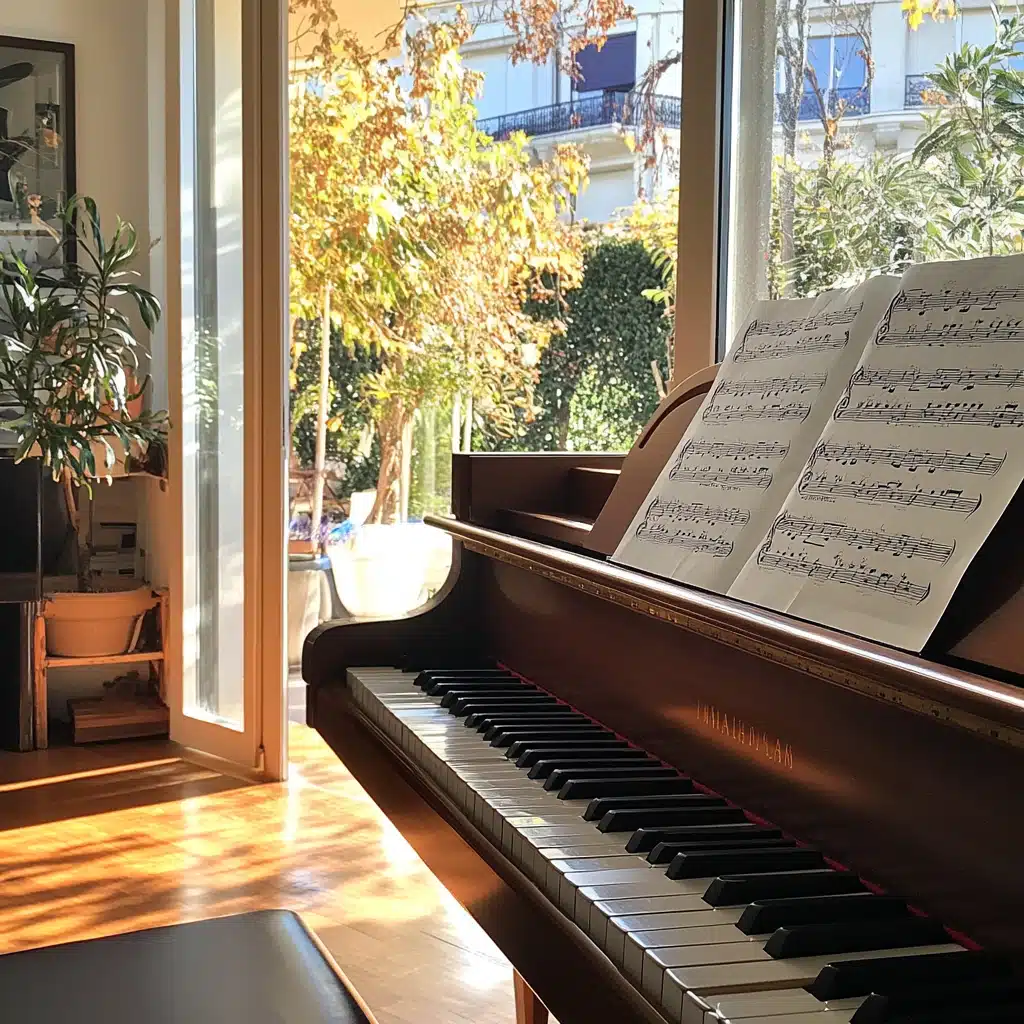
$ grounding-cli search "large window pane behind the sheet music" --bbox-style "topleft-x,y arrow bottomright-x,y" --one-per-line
720,0 -> 1024,344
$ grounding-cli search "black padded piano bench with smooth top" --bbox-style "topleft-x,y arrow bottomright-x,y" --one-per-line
0,910 -> 375,1024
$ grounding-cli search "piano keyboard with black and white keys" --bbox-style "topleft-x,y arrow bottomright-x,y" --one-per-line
348,669 -> 1024,1024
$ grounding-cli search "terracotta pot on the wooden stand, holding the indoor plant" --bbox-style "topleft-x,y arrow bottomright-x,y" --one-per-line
43,587 -> 157,657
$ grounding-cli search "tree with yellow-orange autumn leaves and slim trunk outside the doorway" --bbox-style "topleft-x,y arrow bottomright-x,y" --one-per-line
292,8 -> 586,521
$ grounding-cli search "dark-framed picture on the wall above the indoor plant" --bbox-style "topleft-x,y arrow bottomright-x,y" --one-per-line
0,36 -> 75,267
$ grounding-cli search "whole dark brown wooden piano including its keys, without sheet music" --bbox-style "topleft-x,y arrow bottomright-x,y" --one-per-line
303,368 -> 1024,1024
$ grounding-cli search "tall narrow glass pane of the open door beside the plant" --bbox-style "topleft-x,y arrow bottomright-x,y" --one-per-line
181,0 -> 245,729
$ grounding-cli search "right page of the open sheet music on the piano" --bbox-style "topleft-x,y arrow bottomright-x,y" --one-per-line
729,256 -> 1024,651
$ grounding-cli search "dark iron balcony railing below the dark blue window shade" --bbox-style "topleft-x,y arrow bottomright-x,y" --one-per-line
476,92 -> 683,141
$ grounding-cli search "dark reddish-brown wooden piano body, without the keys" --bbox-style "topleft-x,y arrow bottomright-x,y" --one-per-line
303,368 -> 1024,1024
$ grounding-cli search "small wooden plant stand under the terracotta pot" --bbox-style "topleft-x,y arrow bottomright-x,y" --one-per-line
32,588 -> 167,751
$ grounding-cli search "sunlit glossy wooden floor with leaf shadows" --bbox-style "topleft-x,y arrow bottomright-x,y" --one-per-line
6,724 -> 536,1024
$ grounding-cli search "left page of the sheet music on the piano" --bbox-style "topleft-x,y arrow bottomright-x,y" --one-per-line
612,278 -> 899,593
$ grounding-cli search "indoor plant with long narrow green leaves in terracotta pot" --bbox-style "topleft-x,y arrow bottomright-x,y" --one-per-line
0,197 -> 167,656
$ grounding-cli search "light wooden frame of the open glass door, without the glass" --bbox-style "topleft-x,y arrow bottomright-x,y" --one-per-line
164,0 -> 288,779
